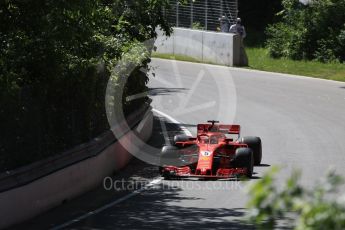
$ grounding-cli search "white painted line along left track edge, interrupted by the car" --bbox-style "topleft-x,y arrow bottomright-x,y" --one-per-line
52,109 -> 192,230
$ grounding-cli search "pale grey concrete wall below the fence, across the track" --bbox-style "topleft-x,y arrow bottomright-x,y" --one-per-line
155,28 -> 245,66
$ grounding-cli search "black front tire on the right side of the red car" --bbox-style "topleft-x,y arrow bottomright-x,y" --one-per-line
232,148 -> 254,178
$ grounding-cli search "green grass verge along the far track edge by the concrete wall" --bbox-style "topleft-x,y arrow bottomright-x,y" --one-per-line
152,47 -> 345,82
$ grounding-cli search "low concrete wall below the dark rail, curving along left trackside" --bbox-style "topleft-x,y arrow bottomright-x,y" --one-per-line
0,107 -> 153,228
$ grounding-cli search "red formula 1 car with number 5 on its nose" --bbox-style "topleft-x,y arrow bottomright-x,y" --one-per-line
159,121 -> 262,179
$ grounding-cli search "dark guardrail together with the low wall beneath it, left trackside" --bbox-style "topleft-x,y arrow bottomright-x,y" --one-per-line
0,107 -> 153,228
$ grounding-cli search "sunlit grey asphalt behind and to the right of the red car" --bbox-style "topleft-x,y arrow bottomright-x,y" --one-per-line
151,59 -> 345,183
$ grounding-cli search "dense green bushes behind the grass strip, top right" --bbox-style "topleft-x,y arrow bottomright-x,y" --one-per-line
266,0 -> 345,62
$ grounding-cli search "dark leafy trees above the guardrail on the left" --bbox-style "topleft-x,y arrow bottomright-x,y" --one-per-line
0,0 -> 171,171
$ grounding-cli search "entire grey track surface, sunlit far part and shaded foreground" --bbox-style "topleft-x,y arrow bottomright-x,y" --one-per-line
14,59 -> 345,229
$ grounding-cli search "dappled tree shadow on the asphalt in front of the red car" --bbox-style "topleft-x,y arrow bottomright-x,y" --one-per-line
71,184 -> 254,229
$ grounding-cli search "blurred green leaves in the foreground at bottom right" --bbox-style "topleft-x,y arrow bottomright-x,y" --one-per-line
248,168 -> 345,230
